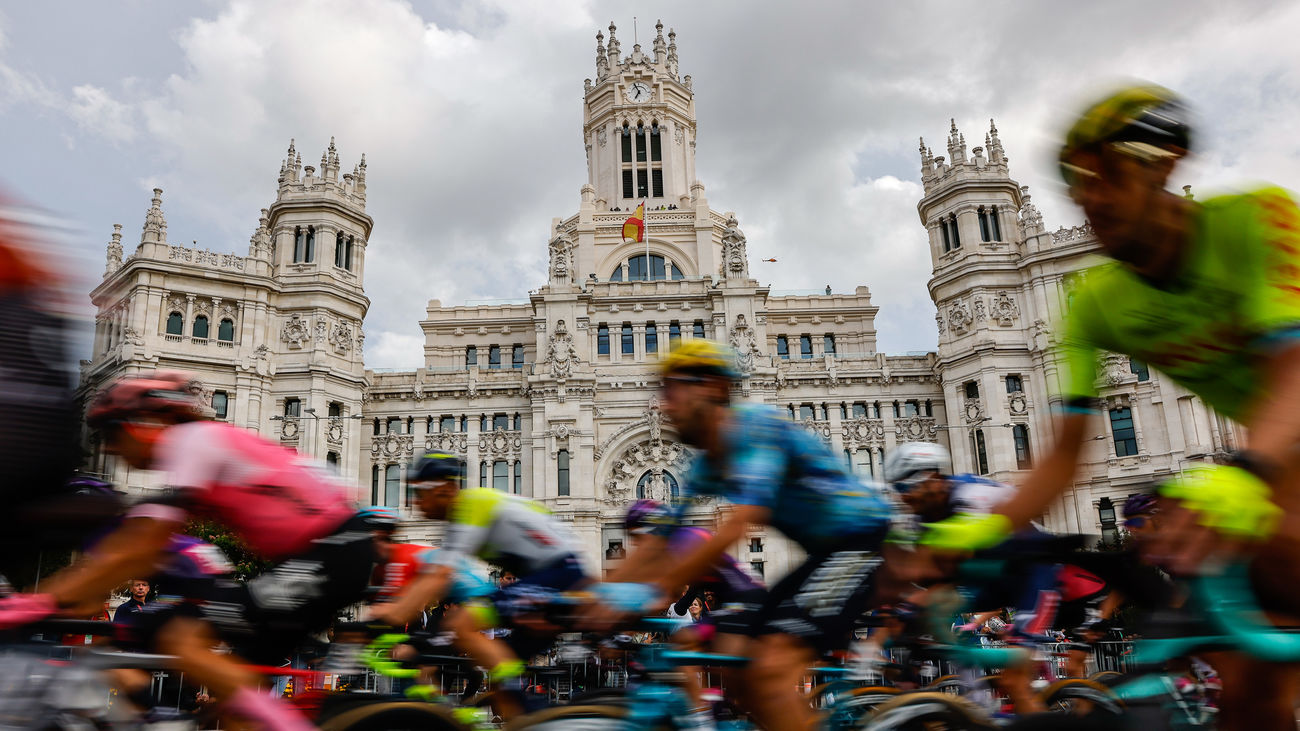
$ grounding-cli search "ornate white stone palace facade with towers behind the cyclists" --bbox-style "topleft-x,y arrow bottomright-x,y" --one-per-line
83,23 -> 1239,576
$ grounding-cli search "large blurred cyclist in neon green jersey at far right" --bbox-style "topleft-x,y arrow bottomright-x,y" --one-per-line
928,86 -> 1300,730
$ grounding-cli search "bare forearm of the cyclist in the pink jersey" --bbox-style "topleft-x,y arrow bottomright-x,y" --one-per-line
42,509 -> 181,607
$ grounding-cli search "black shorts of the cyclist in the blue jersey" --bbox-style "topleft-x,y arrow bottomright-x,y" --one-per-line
755,549 -> 881,653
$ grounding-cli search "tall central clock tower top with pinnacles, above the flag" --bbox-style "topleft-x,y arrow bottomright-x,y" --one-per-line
582,22 -> 696,211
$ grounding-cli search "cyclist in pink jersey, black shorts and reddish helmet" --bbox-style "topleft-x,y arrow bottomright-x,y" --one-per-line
0,372 -> 374,730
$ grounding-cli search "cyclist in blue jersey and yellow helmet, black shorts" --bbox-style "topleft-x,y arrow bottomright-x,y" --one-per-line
618,338 -> 891,728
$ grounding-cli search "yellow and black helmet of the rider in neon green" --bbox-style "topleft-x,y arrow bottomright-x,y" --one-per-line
1058,85 -> 1191,185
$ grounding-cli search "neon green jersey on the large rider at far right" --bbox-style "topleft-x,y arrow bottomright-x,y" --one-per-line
1062,187 -> 1300,419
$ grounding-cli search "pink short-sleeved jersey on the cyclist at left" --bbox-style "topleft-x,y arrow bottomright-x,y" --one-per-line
133,421 -> 356,559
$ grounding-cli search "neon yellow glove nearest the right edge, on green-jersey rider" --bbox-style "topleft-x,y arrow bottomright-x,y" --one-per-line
1160,464 -> 1282,540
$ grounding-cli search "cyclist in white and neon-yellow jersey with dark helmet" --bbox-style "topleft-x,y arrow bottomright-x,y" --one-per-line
374,453 -> 588,718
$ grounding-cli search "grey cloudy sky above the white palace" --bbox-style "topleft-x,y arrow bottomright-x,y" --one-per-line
0,0 -> 1300,367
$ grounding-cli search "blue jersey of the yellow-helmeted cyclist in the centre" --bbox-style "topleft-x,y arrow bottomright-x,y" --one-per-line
686,403 -> 892,553
